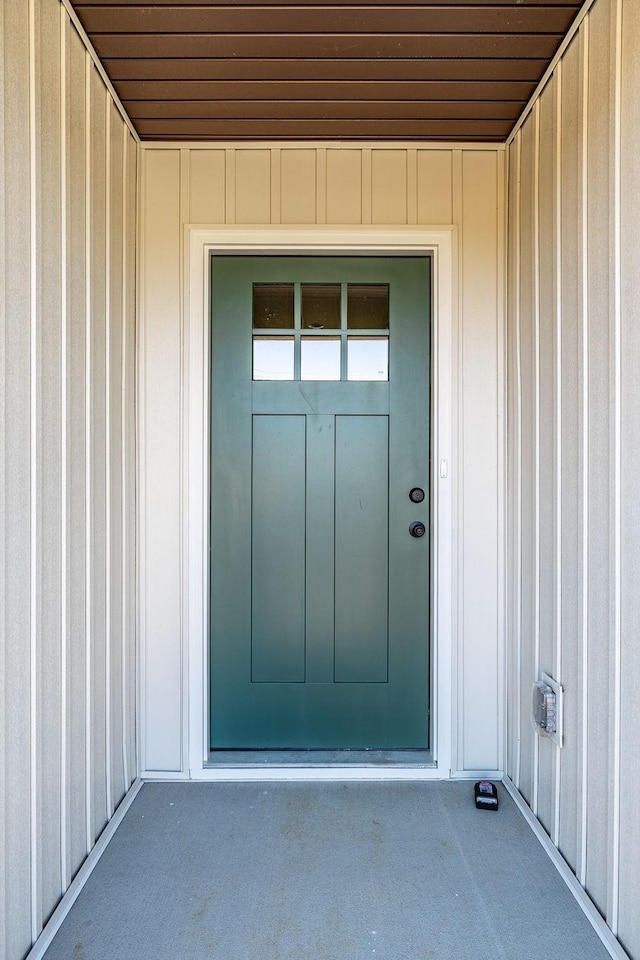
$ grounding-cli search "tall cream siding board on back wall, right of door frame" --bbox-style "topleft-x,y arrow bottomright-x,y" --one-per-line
458,151 -> 503,770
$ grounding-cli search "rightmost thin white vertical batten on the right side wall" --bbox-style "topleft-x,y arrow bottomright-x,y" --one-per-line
607,0 -> 622,936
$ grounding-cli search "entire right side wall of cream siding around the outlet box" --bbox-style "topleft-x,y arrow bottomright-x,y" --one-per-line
507,0 -> 640,957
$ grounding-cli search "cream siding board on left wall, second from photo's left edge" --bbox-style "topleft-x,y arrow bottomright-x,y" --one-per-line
35,2 -> 62,916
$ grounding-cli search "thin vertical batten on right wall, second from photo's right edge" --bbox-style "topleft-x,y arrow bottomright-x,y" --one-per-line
577,16 -> 590,887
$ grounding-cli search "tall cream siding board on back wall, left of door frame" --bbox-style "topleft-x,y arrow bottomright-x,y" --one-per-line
141,150 -> 183,770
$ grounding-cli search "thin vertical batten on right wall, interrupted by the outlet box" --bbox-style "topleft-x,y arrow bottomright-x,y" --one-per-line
552,61 -> 562,846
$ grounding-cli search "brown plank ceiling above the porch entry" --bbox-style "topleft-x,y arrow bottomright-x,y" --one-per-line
74,0 -> 582,142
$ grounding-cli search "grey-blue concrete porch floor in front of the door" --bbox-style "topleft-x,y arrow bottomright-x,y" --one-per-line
45,782 -> 609,960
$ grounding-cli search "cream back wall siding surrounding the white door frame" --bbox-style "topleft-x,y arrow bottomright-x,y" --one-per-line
139,144 -> 504,776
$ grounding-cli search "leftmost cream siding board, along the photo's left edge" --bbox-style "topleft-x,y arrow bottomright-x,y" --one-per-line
0,0 -> 35,957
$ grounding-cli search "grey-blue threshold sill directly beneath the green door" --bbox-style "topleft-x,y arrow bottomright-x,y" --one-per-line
204,750 -> 437,769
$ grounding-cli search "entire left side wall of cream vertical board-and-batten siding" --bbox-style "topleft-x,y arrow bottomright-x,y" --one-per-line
0,0 -> 137,960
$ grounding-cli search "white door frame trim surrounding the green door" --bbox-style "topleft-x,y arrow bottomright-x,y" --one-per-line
181,224 -> 458,780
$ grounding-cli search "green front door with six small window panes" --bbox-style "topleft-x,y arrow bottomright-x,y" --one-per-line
211,256 -> 430,749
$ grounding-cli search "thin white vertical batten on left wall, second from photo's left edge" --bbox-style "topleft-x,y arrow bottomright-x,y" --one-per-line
60,4 -> 71,892
